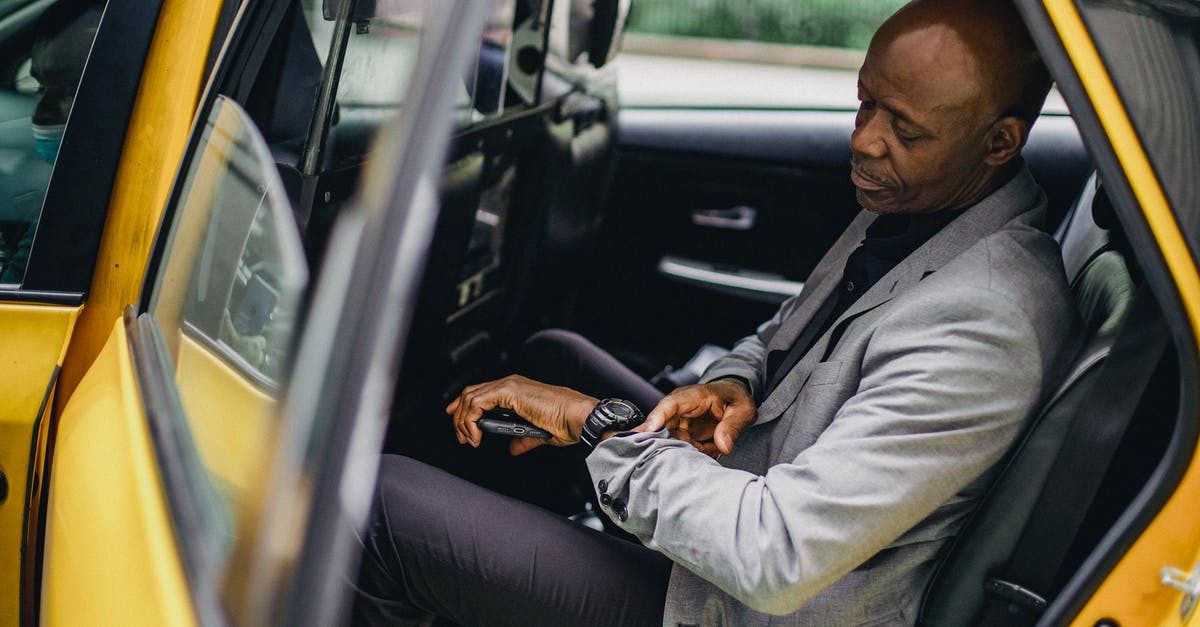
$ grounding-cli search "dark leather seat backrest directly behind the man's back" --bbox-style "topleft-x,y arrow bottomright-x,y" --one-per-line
918,175 -> 1134,627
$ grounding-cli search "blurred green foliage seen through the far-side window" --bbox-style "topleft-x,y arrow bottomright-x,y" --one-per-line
626,0 -> 905,49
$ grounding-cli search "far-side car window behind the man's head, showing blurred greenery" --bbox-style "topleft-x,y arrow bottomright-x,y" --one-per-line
619,0 -> 1066,113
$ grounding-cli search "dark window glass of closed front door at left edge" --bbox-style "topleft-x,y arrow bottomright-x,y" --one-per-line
0,1 -> 104,287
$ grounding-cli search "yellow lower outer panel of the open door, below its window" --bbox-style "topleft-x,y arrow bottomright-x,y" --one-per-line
41,321 -> 194,626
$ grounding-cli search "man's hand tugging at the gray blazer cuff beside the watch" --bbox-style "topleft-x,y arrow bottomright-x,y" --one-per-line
635,378 -> 758,456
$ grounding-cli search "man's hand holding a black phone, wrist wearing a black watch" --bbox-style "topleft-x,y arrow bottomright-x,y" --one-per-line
446,375 -> 600,455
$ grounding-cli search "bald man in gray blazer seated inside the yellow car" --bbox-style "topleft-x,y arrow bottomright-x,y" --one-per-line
358,0 -> 1076,626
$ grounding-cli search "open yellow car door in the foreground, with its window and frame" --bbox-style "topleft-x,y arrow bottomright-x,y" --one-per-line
40,0 -> 496,626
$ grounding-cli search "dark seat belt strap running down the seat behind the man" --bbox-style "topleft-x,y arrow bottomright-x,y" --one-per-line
978,286 -> 1170,627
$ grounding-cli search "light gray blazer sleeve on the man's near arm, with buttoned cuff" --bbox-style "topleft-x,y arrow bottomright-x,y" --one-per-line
588,287 -> 1046,614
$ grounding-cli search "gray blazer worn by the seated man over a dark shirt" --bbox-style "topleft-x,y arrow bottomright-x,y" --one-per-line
588,171 -> 1079,626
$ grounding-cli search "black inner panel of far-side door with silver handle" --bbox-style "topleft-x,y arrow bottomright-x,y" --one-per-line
582,103 -> 1090,363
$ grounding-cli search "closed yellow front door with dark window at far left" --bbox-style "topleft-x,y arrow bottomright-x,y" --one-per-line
0,0 -> 223,625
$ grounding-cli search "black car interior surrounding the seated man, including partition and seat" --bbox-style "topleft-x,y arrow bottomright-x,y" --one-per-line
9,0 -> 1181,626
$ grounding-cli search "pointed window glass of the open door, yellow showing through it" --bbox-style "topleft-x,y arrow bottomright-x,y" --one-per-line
150,97 -> 307,542
